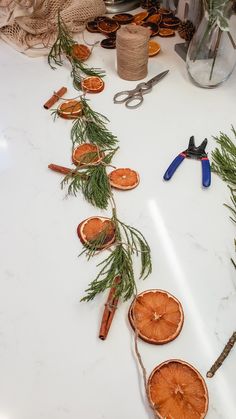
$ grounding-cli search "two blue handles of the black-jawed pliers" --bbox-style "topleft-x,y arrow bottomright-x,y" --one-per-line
164,152 -> 211,188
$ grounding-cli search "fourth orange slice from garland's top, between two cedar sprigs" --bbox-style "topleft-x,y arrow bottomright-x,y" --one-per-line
72,143 -> 104,166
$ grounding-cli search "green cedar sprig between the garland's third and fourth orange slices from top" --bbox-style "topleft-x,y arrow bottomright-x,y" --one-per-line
71,98 -> 117,149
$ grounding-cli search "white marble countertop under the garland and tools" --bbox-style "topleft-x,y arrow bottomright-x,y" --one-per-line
0,15 -> 236,419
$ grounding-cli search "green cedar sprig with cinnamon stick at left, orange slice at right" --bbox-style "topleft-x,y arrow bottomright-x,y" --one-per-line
61,148 -> 118,209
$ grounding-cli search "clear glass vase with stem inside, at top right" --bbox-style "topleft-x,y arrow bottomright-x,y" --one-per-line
186,2 -> 236,88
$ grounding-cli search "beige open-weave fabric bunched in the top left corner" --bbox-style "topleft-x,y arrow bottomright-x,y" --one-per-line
0,0 -> 105,56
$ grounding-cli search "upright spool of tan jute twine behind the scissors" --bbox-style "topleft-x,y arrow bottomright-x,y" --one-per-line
116,24 -> 150,80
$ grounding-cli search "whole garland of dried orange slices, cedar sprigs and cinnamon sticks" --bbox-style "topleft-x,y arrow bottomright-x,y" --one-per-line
46,13 -> 208,419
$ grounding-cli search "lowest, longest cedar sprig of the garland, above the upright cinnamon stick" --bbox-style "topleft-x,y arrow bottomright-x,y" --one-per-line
81,210 -> 152,301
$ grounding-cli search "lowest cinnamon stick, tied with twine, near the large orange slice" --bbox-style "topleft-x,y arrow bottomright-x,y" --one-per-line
99,276 -> 121,340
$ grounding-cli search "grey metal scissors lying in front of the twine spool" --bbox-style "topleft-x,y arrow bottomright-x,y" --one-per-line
113,70 -> 169,109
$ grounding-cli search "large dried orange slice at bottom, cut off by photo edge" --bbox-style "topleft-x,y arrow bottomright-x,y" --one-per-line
147,359 -> 208,419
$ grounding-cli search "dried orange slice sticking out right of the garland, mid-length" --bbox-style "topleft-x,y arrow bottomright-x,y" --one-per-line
108,169 -> 139,190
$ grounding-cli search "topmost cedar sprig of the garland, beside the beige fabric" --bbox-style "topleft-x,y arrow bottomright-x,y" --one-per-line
48,11 -> 105,83
